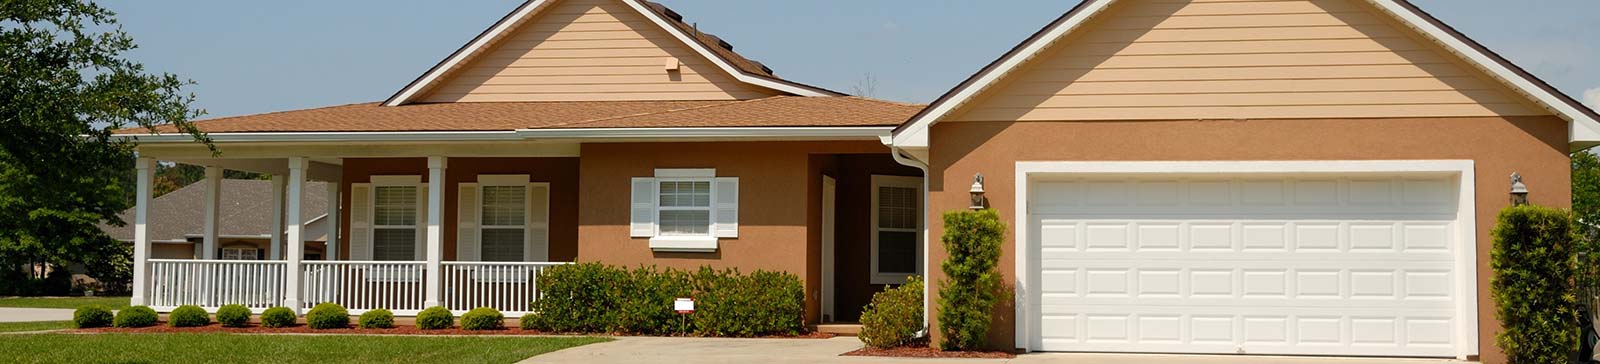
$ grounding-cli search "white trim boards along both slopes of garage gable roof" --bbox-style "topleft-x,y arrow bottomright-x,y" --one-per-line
893,0 -> 1600,150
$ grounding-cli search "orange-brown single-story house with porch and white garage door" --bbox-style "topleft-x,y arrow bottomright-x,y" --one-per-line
123,0 -> 1600,362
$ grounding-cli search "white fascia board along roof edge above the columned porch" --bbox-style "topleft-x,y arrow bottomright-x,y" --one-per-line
115,131 -> 522,144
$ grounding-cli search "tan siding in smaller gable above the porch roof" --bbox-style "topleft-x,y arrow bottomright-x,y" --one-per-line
421,0 -> 776,102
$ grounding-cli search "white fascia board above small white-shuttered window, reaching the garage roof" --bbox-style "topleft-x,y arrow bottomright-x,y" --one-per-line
517,126 -> 894,140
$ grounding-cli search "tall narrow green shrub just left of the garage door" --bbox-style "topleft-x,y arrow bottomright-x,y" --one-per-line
939,209 -> 1005,350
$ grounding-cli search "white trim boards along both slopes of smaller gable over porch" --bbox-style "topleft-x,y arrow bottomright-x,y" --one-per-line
384,0 -> 840,107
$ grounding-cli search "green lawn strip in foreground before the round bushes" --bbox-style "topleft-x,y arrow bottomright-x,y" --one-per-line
0,334 -> 610,364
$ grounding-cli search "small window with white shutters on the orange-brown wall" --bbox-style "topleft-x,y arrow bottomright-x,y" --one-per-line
629,168 -> 739,252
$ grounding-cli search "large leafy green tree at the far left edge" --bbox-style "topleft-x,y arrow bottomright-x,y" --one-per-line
0,0 -> 214,294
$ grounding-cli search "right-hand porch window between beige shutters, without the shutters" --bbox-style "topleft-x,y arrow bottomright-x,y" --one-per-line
480,184 -> 528,262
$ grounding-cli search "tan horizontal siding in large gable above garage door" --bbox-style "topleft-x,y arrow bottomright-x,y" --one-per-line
946,0 -> 1549,121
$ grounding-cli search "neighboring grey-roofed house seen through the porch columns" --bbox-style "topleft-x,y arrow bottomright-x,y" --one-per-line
101,179 -> 331,260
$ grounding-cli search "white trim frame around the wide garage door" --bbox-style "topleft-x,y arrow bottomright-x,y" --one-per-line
1013,160 -> 1478,359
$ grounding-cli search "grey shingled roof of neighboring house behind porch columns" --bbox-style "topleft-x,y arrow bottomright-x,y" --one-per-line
101,179 -> 328,243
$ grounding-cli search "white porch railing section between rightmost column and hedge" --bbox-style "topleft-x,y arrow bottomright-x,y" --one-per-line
442,262 -> 565,316
